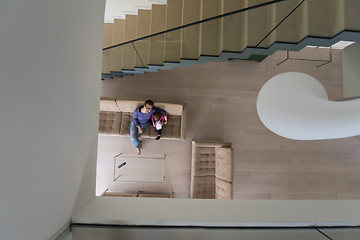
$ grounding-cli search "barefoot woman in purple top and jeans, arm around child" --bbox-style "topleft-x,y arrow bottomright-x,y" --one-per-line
130,100 -> 167,155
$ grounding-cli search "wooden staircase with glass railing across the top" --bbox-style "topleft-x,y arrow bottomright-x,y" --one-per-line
102,0 -> 360,79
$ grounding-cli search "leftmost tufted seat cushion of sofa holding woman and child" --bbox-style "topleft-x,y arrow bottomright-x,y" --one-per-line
99,111 -> 121,134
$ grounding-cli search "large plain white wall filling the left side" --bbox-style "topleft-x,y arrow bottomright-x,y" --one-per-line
0,0 -> 105,240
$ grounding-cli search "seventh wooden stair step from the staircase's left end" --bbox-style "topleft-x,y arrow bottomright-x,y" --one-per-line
182,0 -> 201,59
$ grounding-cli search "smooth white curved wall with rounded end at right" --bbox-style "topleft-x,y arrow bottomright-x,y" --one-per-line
257,72 -> 360,140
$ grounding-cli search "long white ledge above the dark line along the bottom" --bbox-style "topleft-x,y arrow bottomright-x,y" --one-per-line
72,197 -> 360,227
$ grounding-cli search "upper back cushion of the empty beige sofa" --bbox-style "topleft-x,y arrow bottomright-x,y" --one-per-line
215,147 -> 234,182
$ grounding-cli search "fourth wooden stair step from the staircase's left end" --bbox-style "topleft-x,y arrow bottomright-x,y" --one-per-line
134,10 -> 151,67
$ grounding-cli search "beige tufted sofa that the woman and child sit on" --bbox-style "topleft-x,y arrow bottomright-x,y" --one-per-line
99,98 -> 186,139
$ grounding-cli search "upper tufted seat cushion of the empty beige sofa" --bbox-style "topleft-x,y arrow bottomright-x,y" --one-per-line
191,147 -> 215,176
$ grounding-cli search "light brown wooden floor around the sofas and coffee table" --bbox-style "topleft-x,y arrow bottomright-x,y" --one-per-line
97,48 -> 360,199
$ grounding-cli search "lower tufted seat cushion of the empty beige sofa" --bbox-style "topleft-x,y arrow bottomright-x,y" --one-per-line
190,176 -> 215,199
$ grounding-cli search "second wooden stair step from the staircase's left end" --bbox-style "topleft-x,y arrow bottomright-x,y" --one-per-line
110,19 -> 125,72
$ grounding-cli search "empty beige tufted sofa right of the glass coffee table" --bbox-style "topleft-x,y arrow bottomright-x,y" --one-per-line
190,141 -> 234,199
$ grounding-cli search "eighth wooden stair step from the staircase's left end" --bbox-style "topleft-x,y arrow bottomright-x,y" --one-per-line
200,0 -> 222,56
